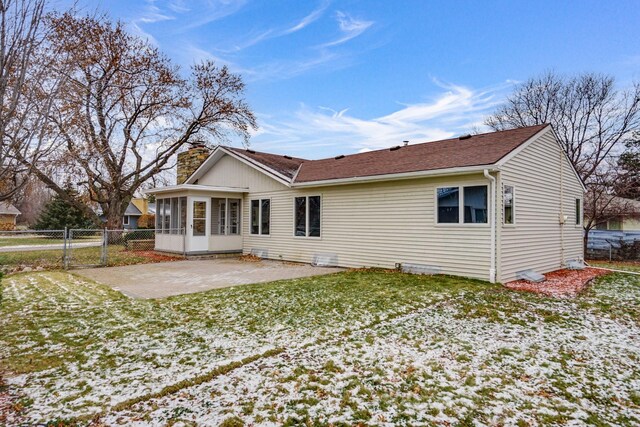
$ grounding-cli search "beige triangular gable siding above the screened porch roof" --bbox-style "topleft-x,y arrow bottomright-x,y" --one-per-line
198,155 -> 287,191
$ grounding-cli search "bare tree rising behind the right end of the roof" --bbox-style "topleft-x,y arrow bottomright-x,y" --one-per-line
486,72 -> 640,184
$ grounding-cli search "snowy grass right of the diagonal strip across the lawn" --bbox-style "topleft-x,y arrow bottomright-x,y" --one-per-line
102,276 -> 640,426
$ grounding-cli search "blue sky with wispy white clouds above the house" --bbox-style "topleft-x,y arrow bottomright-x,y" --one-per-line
85,0 -> 640,158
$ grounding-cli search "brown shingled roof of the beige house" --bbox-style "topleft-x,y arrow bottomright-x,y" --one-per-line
218,124 -> 549,184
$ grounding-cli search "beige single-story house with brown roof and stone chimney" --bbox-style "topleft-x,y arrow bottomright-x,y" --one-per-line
149,125 -> 584,282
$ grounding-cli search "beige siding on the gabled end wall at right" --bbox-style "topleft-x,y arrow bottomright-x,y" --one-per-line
499,130 -> 583,282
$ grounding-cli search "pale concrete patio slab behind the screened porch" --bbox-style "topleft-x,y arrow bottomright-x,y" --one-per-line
74,259 -> 344,298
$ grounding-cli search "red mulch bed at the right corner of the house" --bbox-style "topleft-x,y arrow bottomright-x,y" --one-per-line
504,268 -> 609,298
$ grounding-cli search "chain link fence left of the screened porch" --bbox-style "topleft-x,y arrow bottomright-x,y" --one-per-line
0,229 -> 185,273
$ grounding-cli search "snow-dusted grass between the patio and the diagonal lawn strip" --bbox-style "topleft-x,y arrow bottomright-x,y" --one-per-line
0,272 -> 484,422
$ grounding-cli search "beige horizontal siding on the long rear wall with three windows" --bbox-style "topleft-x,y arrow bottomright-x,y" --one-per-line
243,175 -> 490,280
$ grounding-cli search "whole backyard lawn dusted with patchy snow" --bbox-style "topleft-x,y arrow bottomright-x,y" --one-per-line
0,271 -> 640,426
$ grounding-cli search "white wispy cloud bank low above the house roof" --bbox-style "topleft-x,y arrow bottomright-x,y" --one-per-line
253,82 -> 511,157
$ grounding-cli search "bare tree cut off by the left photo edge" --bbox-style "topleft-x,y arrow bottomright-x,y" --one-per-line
0,0 -> 65,200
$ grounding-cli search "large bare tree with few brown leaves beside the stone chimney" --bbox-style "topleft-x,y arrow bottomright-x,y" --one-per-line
22,13 -> 256,228
